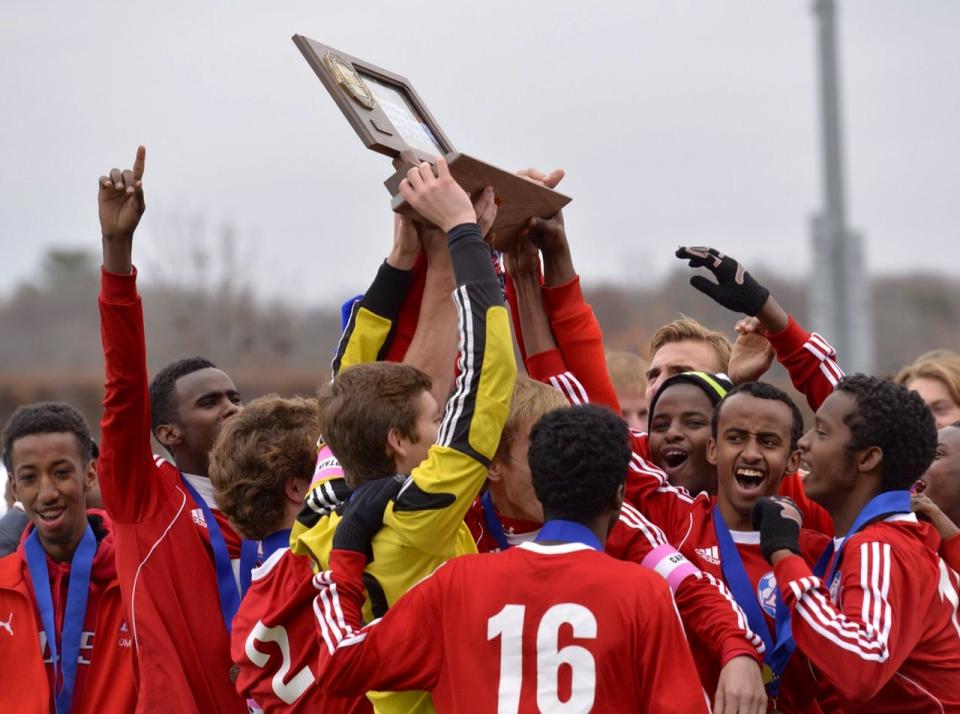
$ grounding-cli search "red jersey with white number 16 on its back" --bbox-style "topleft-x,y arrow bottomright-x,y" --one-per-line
316,543 -> 708,713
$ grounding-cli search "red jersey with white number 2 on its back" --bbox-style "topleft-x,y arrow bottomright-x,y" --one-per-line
230,548 -> 373,714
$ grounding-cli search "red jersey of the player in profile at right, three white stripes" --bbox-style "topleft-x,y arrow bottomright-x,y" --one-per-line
775,514 -> 960,714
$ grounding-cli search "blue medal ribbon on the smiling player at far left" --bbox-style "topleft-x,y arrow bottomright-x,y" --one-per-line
24,523 -> 97,714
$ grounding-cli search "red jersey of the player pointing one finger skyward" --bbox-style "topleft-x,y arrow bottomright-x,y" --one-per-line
97,271 -> 246,712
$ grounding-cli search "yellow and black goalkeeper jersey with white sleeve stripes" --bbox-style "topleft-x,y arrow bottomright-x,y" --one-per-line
292,224 -> 517,714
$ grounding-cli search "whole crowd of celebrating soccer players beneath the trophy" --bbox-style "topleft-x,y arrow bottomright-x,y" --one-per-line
0,147 -> 960,714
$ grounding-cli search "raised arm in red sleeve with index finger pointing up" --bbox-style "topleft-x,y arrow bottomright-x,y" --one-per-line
97,146 -> 170,523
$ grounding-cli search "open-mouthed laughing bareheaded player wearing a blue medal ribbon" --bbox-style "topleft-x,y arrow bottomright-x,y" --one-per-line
608,382 -> 827,711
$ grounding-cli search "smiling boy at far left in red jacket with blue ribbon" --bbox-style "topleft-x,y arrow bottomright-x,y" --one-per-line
0,402 -> 136,714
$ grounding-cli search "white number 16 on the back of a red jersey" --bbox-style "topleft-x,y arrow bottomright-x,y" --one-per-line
487,603 -> 597,714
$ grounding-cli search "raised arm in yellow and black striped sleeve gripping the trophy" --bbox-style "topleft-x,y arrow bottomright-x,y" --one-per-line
384,158 -> 516,553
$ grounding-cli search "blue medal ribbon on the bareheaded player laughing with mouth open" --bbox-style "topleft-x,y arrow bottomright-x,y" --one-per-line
713,506 -> 797,697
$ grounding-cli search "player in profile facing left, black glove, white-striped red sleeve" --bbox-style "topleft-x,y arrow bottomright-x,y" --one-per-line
755,374 -> 960,713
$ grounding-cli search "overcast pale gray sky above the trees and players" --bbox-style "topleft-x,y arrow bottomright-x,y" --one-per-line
0,0 -> 960,303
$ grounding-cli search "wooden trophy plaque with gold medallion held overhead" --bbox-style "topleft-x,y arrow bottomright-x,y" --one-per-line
293,35 -> 570,249
